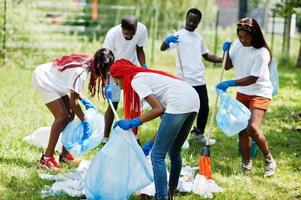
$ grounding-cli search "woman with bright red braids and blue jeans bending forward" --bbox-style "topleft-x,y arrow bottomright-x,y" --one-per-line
100,56 -> 200,199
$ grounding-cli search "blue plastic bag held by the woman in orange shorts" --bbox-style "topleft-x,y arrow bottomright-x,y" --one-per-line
216,89 -> 251,136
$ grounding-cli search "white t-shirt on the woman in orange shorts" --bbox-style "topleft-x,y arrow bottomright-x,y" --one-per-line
229,40 -> 273,99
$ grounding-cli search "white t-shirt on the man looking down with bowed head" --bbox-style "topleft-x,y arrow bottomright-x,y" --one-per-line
103,22 -> 147,64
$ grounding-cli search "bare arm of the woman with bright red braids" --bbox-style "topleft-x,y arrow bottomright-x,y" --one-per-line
140,94 -> 165,123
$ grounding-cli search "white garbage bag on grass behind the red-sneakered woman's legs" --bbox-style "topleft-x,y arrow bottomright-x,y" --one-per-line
23,126 -> 63,151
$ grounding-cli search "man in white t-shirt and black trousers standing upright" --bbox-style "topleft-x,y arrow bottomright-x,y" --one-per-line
161,8 -> 223,143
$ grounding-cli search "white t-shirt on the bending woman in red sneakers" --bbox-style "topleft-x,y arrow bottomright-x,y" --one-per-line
33,63 -> 87,94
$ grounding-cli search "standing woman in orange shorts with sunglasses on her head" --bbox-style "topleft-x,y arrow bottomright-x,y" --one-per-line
216,18 -> 276,176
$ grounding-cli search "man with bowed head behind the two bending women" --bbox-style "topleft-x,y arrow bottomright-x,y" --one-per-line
103,16 -> 147,143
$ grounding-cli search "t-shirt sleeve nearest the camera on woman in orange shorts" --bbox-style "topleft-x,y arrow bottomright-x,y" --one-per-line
250,49 -> 270,77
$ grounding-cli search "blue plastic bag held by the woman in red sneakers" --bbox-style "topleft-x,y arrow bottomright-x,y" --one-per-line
62,101 -> 104,156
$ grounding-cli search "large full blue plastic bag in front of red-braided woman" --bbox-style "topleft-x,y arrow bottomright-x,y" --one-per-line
85,127 -> 153,200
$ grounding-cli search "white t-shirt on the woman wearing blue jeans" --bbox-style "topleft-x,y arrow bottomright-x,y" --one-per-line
131,72 -> 200,114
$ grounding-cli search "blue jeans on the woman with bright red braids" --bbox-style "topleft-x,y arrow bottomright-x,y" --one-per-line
151,112 -> 196,200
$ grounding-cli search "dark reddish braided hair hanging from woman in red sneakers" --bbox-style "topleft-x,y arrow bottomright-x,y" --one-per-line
89,48 -> 115,97
